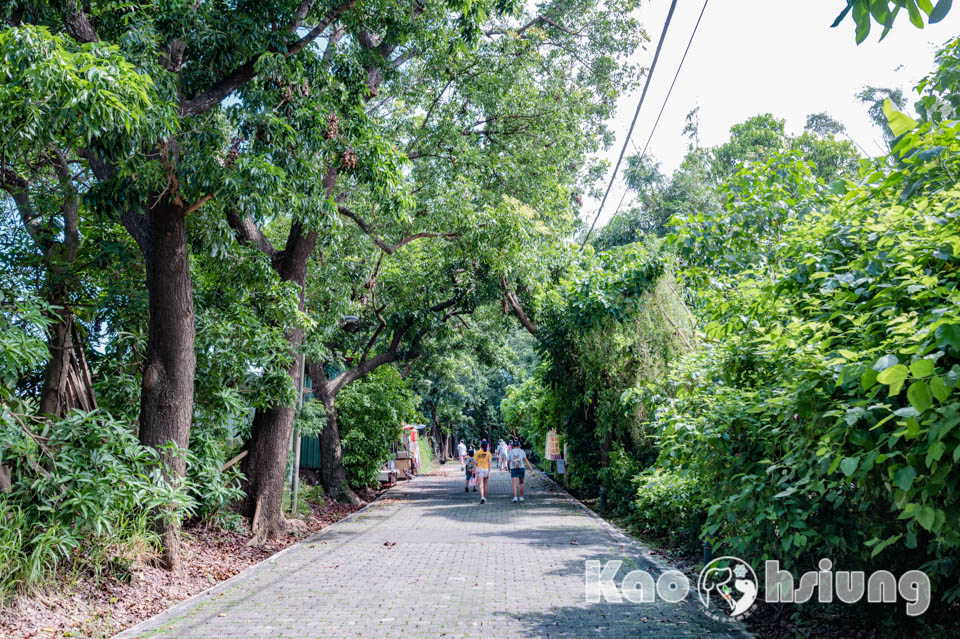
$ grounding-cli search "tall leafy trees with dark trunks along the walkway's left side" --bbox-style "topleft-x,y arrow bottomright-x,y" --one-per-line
0,0 -> 645,594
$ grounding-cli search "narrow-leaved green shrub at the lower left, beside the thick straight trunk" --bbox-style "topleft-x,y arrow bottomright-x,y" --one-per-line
0,407 -> 194,597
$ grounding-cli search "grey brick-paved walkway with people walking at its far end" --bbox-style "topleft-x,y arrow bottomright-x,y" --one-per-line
118,463 -> 746,639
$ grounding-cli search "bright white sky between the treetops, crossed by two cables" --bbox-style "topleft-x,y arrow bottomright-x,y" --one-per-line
581,0 -> 960,226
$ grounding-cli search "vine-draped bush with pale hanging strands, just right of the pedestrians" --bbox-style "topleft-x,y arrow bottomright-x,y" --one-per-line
501,244 -> 692,496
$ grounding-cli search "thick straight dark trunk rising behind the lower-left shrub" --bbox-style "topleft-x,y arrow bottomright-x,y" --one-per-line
140,204 -> 197,571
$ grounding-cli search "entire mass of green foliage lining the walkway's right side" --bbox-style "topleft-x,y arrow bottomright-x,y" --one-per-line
503,32 -> 960,622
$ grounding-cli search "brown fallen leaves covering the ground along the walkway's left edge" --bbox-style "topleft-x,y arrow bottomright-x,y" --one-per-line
0,493 -> 376,639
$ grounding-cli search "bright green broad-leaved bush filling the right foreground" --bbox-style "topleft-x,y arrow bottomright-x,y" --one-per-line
656,50 -> 960,601
